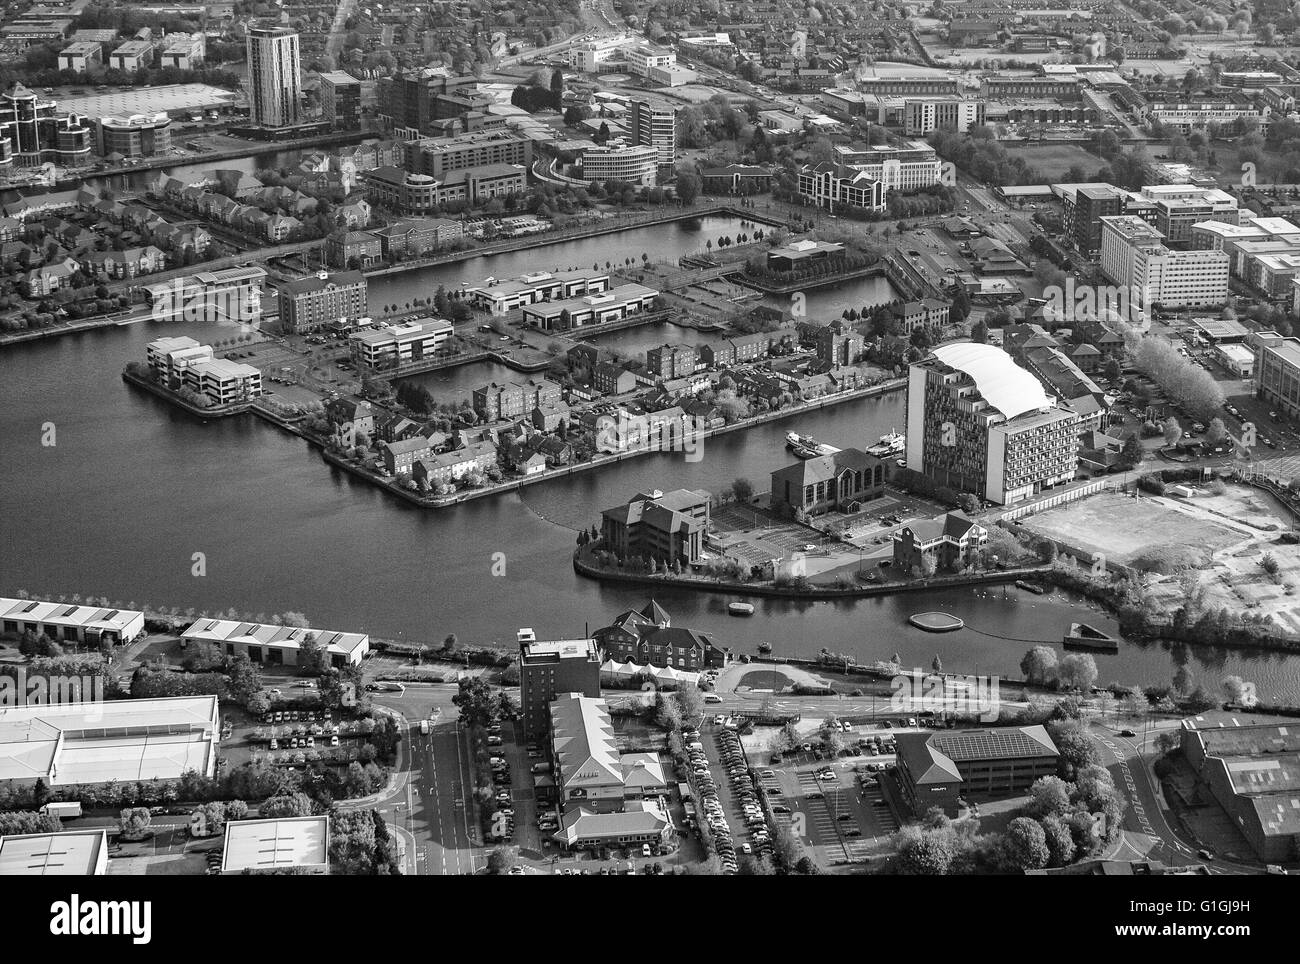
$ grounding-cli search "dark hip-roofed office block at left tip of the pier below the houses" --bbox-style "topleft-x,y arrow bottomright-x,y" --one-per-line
601,488 -> 712,566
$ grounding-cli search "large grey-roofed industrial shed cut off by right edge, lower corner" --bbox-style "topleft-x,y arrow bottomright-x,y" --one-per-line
1180,711 -> 1300,863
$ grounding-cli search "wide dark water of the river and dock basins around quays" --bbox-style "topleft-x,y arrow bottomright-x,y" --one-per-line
0,225 -> 1300,702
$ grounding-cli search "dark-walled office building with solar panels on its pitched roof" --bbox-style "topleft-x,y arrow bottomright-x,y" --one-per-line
896,726 -> 1061,817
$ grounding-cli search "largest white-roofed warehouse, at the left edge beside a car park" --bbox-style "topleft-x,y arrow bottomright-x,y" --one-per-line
0,696 -> 221,787
